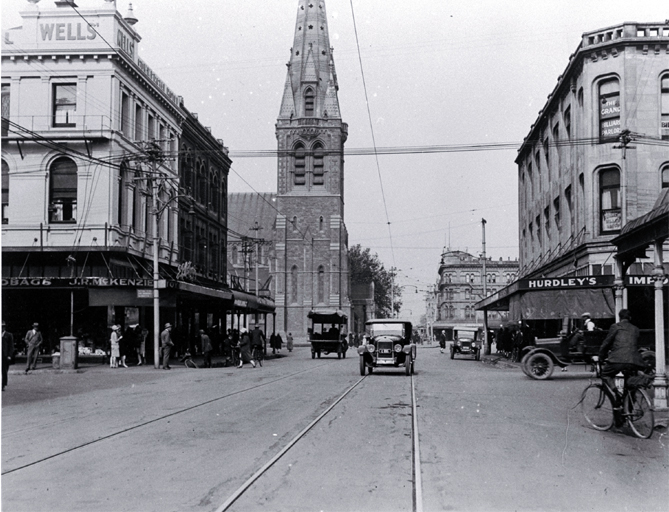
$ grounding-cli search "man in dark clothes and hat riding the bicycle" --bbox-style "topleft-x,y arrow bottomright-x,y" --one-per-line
599,309 -> 644,392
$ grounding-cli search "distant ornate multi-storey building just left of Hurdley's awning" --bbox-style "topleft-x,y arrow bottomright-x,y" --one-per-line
433,249 -> 518,331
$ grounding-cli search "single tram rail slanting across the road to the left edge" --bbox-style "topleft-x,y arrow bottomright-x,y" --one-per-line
0,362 -> 331,476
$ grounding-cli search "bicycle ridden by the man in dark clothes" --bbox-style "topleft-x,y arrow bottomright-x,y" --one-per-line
580,356 -> 655,439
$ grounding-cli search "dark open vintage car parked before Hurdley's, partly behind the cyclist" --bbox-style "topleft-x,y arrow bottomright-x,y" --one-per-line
520,329 -> 655,380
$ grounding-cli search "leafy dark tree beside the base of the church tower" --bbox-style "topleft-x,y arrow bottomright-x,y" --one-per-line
348,244 -> 402,318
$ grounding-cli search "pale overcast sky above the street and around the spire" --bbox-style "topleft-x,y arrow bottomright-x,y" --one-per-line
1,0 -> 669,321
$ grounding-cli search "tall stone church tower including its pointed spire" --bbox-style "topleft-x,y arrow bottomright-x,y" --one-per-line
275,0 -> 350,339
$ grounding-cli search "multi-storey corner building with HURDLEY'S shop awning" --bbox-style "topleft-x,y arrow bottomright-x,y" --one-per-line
477,21 -> 669,396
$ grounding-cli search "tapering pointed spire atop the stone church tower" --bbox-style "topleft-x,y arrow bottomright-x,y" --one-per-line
279,0 -> 340,119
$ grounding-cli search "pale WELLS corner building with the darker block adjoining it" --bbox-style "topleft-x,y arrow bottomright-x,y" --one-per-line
2,0 -> 241,356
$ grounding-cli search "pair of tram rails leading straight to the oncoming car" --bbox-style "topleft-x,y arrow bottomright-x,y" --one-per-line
216,375 -> 423,512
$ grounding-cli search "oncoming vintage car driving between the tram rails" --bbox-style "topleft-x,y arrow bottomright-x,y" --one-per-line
358,318 -> 416,375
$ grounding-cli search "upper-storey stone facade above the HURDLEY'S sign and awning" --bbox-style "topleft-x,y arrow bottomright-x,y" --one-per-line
516,23 -> 669,288
